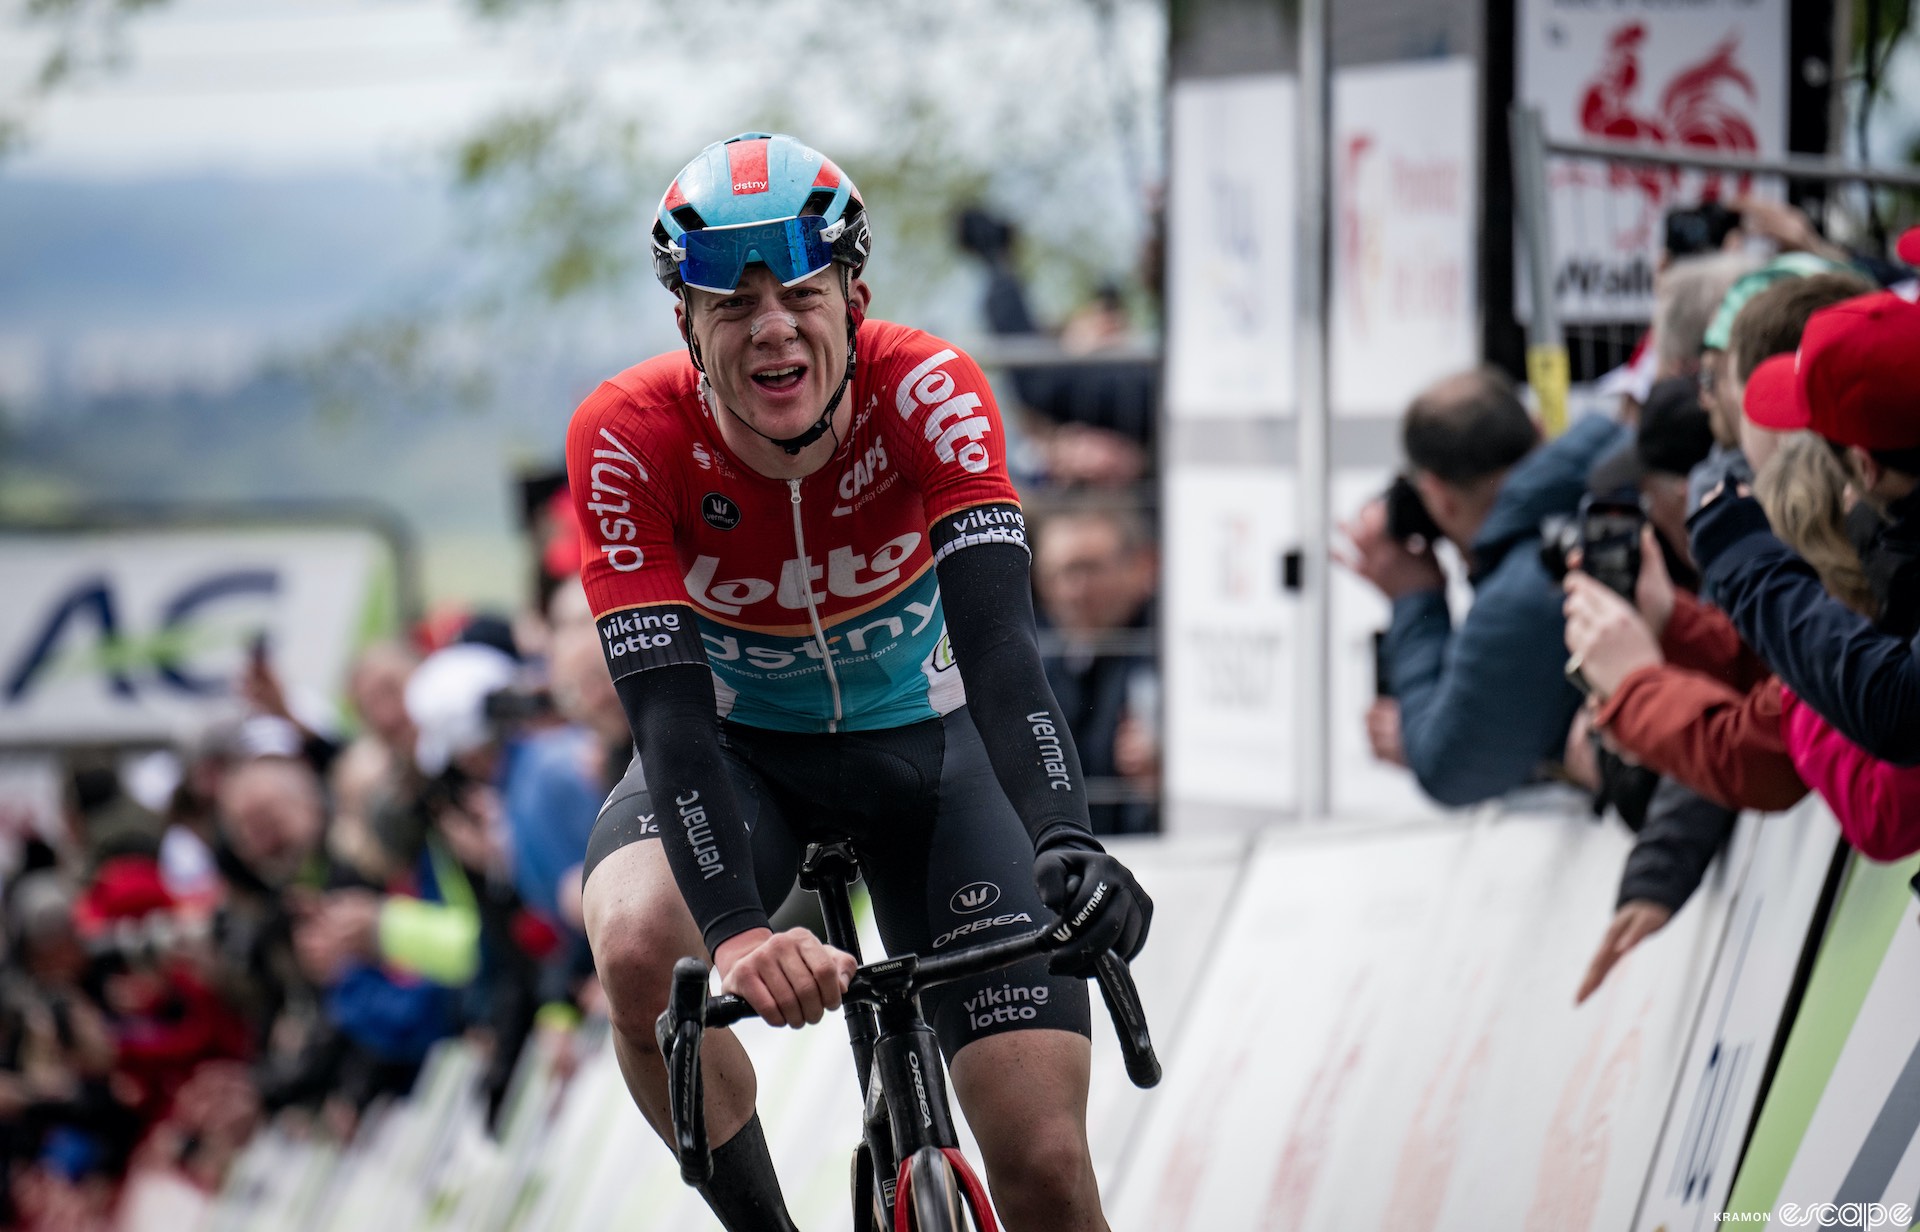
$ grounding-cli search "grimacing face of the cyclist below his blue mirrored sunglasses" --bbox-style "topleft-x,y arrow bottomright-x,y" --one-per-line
680,265 -> 866,438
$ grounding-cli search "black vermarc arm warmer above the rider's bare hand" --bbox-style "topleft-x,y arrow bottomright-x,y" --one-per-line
614,652 -> 770,952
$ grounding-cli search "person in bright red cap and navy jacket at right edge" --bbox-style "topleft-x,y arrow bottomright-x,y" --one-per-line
1690,292 -> 1920,766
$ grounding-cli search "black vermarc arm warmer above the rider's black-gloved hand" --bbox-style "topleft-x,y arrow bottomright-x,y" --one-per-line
929,537 -> 1104,850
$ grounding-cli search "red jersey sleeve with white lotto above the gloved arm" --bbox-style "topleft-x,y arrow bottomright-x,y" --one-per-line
881,332 -> 1027,564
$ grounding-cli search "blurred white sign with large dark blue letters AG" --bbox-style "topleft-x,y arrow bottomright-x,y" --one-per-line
0,530 -> 392,745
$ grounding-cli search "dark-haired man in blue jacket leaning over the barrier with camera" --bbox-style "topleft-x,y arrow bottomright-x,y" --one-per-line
1340,368 -> 1630,806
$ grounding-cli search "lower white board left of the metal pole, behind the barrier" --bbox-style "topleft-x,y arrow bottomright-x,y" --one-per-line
1162,466 -> 1296,813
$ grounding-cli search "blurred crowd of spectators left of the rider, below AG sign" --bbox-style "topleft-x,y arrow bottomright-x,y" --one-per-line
0,583 -> 630,1232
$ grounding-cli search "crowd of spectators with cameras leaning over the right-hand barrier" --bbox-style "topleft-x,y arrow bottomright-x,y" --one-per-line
1340,203 -> 1920,1000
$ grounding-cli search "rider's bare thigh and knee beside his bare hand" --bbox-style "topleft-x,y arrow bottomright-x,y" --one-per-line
580,839 -> 707,1042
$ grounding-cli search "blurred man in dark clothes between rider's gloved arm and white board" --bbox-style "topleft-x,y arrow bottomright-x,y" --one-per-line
1033,505 -> 1158,835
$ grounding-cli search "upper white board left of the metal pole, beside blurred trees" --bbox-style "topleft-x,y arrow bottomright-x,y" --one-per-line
1165,75 -> 1298,418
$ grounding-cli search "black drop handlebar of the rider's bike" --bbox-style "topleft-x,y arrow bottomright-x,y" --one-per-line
653,929 -> 1160,1184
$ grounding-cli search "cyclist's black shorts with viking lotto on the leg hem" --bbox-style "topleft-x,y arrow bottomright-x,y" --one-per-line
584,708 -> 1092,1061
